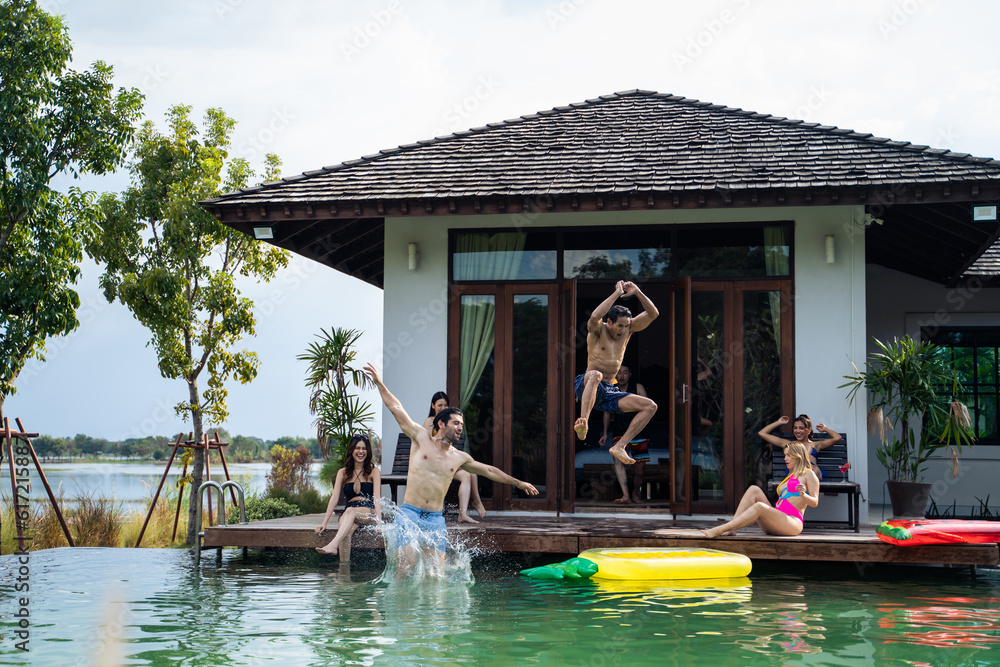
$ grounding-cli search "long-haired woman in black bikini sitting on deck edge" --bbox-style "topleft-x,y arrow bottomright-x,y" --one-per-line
314,435 -> 382,560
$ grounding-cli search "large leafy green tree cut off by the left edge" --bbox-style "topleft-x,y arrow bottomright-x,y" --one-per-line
0,0 -> 142,419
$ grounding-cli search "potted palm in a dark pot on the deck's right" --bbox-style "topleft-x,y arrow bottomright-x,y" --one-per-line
841,336 -> 975,518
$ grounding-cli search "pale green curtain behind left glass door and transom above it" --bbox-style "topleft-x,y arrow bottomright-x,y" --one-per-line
455,232 -> 526,410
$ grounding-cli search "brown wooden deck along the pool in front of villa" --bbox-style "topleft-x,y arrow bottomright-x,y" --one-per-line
203,514 -> 1000,566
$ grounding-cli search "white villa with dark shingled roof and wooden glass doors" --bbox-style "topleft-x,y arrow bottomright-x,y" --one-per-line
205,90 -> 1000,521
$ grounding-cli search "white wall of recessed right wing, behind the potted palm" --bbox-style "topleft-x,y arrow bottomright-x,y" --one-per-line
868,265 -> 1000,508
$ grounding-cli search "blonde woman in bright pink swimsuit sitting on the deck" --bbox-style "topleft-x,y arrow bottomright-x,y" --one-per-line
701,442 -> 819,538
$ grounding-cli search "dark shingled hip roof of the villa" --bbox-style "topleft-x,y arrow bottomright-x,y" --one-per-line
206,90 -> 1000,205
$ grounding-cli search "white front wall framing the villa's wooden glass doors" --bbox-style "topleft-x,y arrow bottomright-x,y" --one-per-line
380,206 -> 869,519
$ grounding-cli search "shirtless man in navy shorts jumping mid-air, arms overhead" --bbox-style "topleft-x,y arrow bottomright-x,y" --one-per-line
573,280 -> 660,464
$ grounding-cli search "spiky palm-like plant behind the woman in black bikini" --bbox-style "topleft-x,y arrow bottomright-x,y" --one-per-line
297,327 -> 375,468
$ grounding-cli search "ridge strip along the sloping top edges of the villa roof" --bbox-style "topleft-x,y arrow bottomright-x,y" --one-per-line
209,88 -> 1000,201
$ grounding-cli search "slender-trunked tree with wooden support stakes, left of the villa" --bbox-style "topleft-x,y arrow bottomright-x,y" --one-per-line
88,105 -> 288,545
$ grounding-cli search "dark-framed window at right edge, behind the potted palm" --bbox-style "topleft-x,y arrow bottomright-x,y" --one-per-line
923,327 -> 1000,445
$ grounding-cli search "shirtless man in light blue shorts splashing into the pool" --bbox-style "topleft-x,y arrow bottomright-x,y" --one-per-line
365,364 -> 538,577
